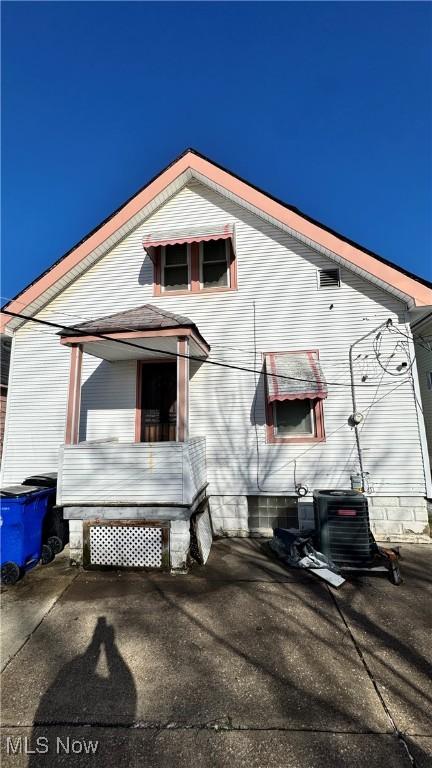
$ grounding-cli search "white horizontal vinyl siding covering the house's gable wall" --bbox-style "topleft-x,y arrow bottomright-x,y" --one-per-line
3,182 -> 425,496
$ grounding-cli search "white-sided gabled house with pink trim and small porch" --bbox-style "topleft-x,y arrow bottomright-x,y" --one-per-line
2,150 -> 432,567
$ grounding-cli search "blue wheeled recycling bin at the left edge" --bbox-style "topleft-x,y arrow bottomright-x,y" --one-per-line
0,485 -> 53,584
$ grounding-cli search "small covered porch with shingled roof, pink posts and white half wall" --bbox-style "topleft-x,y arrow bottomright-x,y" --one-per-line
57,304 -> 210,564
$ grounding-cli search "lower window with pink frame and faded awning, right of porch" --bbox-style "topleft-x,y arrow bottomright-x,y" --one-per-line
264,350 -> 327,443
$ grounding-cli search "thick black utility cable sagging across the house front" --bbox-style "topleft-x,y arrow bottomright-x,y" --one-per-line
3,309 -> 412,388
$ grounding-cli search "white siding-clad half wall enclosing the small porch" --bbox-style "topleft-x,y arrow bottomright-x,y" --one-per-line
57,437 -> 207,506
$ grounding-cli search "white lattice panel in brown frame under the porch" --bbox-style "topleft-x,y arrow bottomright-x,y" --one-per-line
90,525 -> 162,568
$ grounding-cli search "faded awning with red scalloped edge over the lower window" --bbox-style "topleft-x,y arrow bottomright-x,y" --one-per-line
265,352 -> 327,402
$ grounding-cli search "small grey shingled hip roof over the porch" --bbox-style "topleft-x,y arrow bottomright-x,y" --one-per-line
58,304 -> 210,360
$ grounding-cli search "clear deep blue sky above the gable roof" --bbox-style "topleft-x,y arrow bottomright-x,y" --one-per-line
1,2 -> 432,297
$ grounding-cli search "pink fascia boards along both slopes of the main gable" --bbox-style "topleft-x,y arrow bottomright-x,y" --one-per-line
1,152 -> 432,330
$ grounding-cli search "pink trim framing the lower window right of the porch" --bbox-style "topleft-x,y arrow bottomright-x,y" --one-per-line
263,349 -> 326,444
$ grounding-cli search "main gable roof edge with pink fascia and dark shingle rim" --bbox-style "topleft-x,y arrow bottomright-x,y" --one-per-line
2,149 -> 432,329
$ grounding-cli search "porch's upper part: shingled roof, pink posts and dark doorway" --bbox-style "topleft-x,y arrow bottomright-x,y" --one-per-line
59,304 -> 210,445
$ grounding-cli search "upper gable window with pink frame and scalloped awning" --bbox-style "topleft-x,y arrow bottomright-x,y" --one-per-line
144,224 -> 237,296
